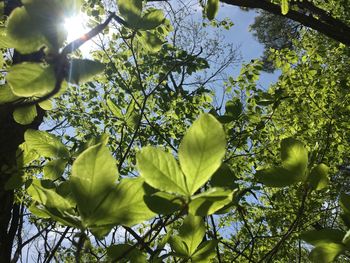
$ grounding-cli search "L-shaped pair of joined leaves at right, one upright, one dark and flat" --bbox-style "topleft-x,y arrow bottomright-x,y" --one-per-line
256,138 -> 308,187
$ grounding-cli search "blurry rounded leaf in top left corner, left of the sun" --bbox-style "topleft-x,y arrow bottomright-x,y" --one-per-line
6,7 -> 47,54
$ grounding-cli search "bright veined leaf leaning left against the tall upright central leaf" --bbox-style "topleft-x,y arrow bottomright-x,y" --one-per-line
136,146 -> 189,195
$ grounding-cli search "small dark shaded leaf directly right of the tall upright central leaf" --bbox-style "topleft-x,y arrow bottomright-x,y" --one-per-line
210,163 -> 237,189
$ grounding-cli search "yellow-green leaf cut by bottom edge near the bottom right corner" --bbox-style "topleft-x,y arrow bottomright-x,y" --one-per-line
310,243 -> 345,263
